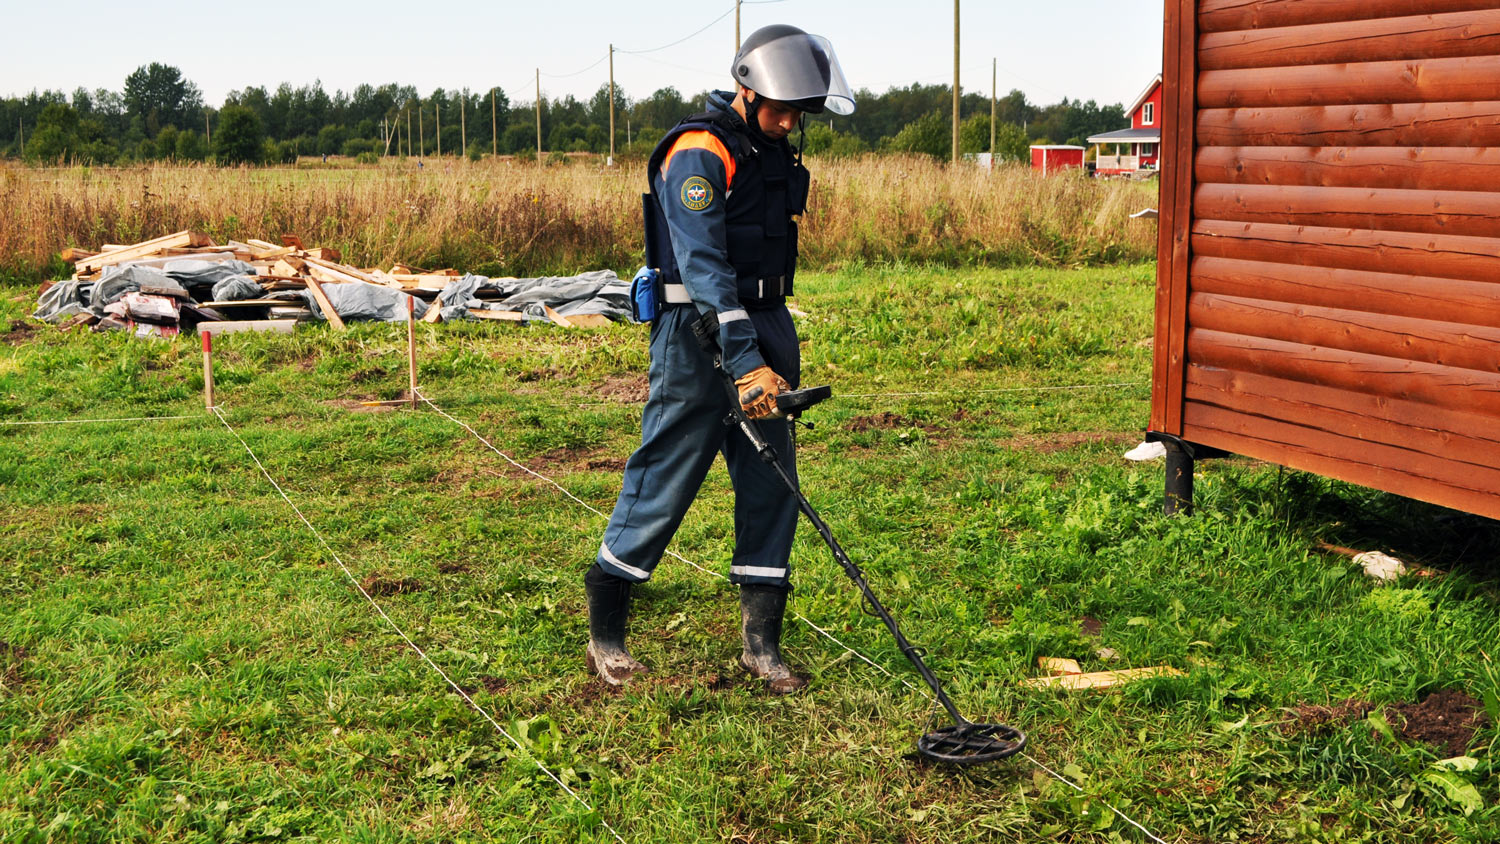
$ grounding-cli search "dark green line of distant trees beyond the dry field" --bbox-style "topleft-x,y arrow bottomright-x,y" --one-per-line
0,63 -> 1128,165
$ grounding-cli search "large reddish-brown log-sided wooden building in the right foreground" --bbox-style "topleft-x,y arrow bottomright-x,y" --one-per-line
1151,0 -> 1500,519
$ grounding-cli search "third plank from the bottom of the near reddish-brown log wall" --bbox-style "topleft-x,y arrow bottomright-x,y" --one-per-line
1188,328 -> 1500,417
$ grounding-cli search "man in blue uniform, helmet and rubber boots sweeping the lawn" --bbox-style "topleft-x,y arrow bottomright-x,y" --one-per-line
584,25 -> 854,694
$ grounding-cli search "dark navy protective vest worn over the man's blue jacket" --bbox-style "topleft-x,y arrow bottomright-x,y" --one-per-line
642,111 -> 809,306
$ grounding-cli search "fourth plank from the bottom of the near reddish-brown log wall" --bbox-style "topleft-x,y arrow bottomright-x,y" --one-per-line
1188,291 -> 1500,373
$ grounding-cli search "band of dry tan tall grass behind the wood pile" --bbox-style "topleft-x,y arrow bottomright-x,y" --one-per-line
0,157 -> 1155,276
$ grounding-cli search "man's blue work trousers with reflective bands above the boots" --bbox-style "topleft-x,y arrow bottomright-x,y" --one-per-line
599,306 -> 803,586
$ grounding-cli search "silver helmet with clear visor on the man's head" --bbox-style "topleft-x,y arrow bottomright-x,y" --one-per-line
729,24 -> 854,114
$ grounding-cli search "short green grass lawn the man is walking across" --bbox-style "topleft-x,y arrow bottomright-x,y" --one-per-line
0,265 -> 1500,844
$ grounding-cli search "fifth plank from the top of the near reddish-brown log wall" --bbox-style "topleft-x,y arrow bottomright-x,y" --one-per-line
1194,147 -> 1500,190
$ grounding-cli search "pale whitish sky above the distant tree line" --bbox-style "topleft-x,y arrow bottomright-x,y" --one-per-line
0,0 -> 1163,106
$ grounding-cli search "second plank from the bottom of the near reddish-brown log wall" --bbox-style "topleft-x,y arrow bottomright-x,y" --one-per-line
1188,364 -> 1500,468
